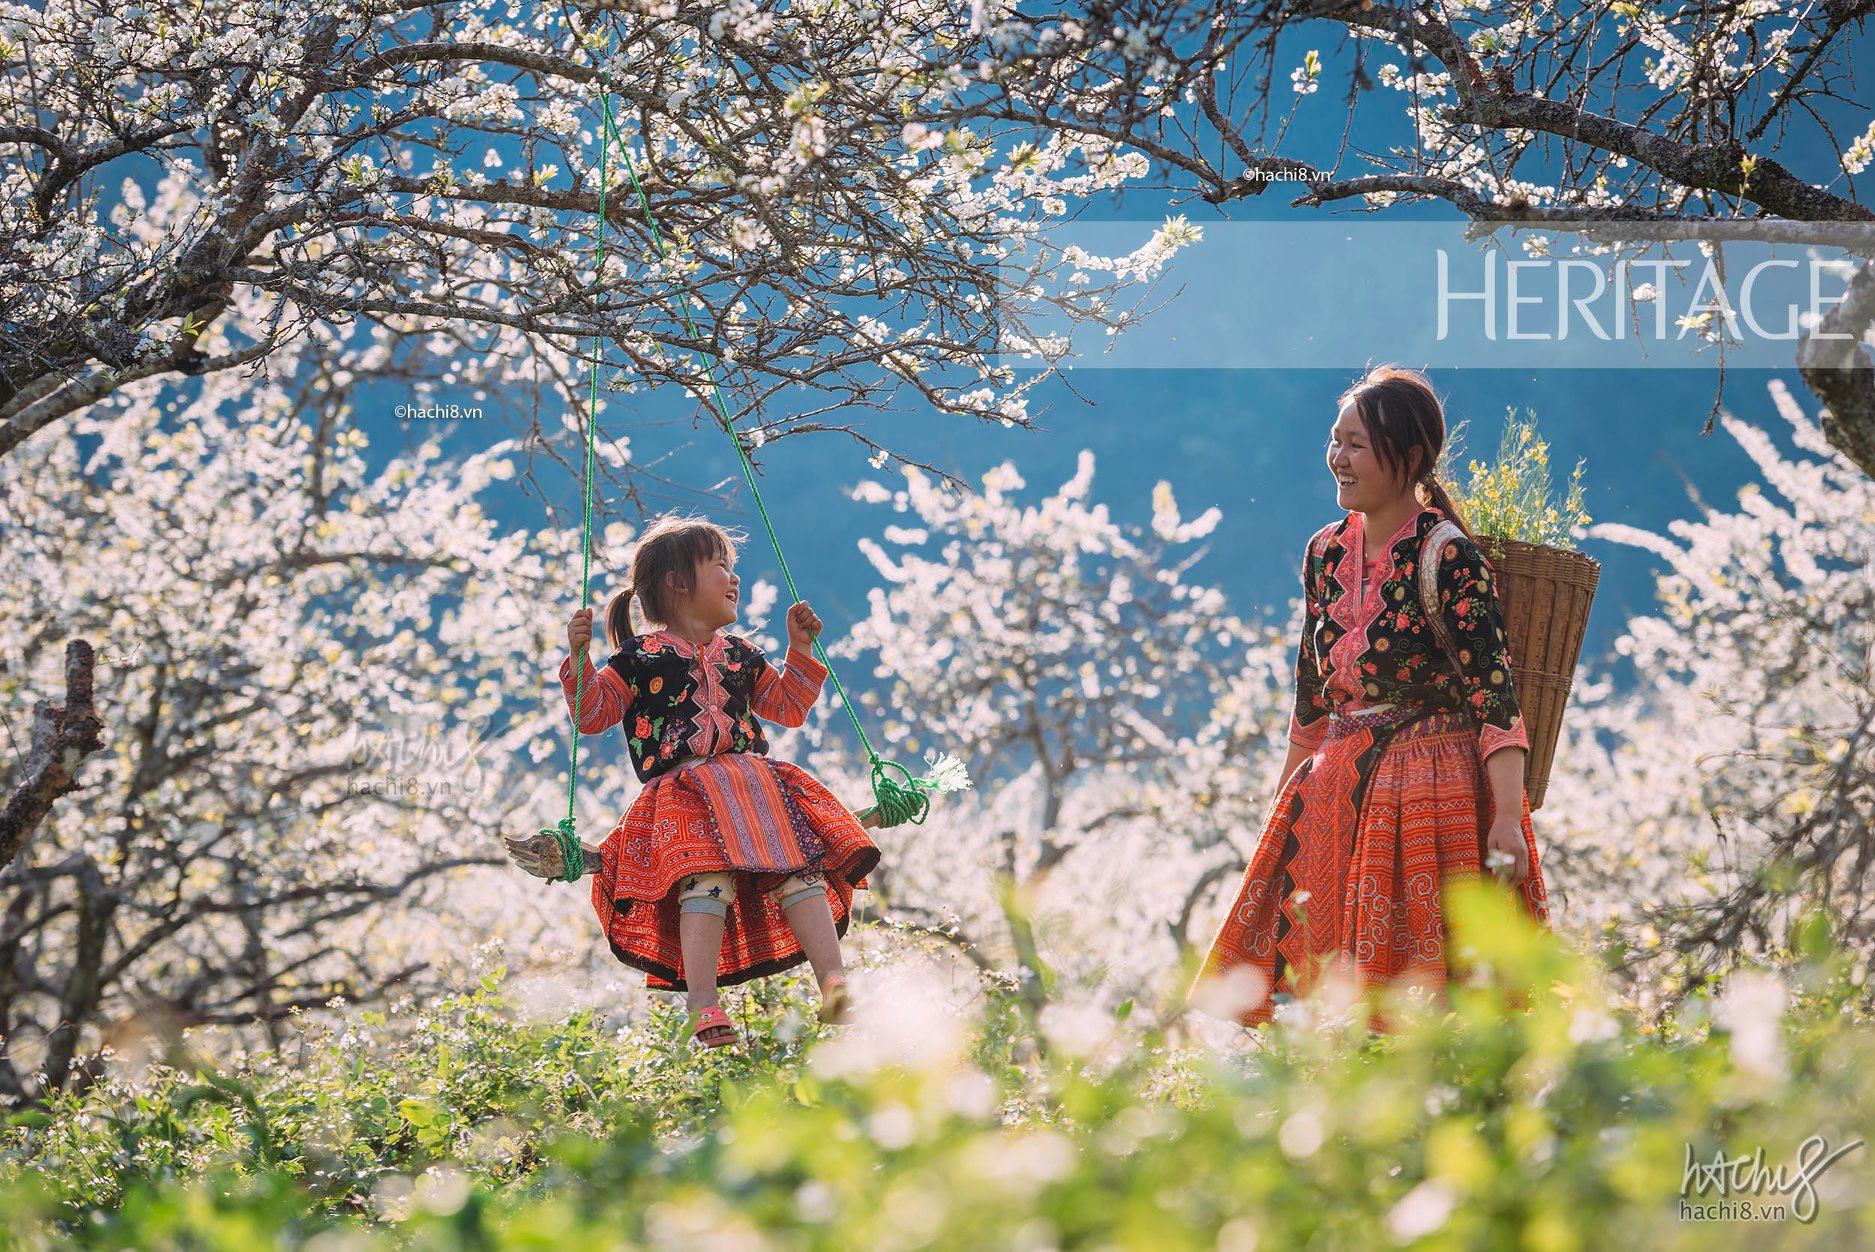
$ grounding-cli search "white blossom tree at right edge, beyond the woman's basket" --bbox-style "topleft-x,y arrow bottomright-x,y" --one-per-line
1543,382 -> 1875,999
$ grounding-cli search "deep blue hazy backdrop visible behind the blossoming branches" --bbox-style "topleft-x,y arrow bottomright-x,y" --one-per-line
364,9 -> 1860,678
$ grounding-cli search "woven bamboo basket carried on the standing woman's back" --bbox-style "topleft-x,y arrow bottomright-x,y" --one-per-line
1478,534 -> 1601,808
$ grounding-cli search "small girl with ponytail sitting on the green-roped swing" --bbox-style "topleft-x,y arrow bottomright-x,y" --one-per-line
508,515 -> 879,1048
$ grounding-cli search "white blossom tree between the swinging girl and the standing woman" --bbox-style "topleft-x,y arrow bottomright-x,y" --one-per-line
838,452 -> 1290,1034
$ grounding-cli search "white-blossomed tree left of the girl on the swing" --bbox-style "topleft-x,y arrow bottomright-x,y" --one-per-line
0,307 -> 596,1102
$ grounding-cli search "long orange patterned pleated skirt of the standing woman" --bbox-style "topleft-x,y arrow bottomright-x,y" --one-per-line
1193,707 -> 1549,1029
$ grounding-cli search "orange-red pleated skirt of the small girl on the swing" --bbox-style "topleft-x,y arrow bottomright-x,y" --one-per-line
593,757 -> 879,991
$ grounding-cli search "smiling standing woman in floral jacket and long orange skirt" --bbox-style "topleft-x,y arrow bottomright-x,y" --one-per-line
1193,365 -> 1549,1029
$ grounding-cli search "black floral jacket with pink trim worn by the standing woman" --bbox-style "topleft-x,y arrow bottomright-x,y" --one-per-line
1290,508 -> 1530,757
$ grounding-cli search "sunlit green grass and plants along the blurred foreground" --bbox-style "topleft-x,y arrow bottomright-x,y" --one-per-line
0,890 -> 1875,1250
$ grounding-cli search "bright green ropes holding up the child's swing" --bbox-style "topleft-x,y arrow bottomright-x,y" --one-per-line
540,44 -> 969,883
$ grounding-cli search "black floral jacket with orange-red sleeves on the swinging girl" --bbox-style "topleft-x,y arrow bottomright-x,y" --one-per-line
561,630 -> 827,782
